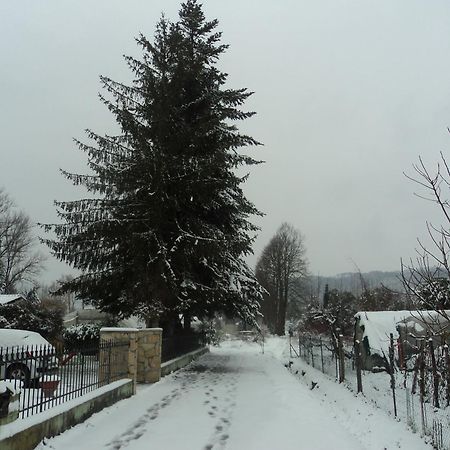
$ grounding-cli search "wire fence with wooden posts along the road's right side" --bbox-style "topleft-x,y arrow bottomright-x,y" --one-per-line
298,333 -> 450,450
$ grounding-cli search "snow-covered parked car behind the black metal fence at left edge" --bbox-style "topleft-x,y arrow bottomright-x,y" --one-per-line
0,329 -> 58,387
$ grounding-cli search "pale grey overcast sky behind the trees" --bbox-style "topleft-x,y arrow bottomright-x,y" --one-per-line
0,0 -> 450,280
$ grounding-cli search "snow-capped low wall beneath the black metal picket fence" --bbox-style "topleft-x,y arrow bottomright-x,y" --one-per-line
0,379 -> 134,450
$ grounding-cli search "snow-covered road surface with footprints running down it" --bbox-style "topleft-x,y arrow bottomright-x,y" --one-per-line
37,338 -> 431,450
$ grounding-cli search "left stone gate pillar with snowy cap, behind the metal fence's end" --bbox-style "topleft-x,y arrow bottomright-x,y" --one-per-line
99,328 -> 138,392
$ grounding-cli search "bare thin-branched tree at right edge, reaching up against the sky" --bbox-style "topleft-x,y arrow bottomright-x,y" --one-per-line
402,153 -> 450,321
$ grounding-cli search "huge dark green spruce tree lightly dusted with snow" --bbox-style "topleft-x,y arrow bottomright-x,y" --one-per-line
42,0 -> 261,330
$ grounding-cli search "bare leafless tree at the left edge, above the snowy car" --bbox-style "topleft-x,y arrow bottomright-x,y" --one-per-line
0,189 -> 43,293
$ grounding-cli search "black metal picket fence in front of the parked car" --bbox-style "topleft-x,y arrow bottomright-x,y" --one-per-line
0,341 -> 129,417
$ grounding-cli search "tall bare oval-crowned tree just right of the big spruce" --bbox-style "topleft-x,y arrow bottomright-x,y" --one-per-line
256,223 -> 307,336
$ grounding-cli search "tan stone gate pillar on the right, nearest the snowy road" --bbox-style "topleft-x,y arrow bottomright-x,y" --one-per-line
137,328 -> 162,383
